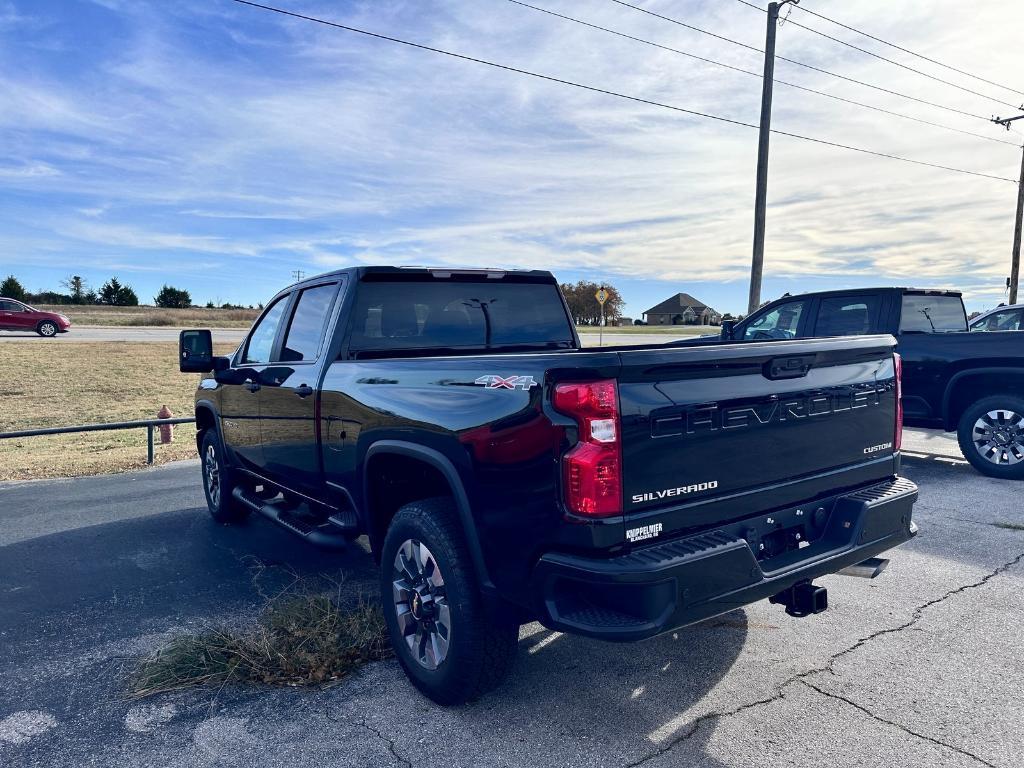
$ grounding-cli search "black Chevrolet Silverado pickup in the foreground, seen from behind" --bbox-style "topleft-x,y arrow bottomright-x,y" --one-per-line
180,267 -> 918,703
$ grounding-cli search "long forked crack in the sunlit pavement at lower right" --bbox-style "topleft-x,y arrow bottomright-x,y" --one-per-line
624,552 -> 1024,768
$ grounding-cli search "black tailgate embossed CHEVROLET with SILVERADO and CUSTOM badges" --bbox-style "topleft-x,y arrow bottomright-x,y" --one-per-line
618,336 -> 896,534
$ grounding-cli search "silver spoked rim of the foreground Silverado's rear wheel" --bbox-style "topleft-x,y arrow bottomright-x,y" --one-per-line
391,539 -> 452,670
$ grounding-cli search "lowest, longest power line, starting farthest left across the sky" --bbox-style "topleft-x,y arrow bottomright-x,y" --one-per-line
231,0 -> 1017,184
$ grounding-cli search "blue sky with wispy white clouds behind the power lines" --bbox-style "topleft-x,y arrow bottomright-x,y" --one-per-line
0,0 -> 1024,316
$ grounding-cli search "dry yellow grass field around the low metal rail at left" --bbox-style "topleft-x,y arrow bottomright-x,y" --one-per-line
0,339 -> 231,480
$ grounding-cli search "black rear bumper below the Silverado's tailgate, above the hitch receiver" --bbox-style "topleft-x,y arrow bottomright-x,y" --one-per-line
531,477 -> 918,641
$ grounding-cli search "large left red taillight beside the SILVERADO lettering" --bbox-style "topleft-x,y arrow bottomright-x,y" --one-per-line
554,379 -> 623,517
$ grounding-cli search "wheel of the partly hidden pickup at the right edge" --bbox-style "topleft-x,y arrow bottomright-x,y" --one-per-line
956,394 -> 1024,480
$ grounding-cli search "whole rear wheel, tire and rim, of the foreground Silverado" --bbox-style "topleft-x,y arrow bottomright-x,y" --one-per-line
381,499 -> 519,705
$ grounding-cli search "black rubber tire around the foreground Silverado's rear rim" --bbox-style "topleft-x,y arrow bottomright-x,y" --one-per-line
381,498 -> 519,706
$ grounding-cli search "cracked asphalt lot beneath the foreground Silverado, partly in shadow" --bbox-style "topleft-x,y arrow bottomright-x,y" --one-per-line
0,448 -> 1024,768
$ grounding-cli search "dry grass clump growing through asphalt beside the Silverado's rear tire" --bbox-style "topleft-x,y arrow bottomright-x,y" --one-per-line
128,590 -> 391,698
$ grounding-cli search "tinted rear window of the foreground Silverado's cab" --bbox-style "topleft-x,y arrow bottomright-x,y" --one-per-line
349,280 -> 573,350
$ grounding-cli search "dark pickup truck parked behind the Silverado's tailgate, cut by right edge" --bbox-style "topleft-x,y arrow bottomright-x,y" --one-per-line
722,288 -> 1024,480
